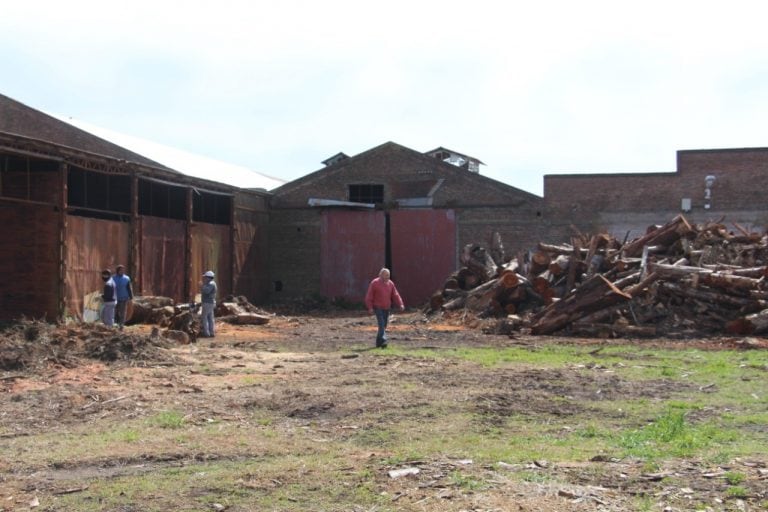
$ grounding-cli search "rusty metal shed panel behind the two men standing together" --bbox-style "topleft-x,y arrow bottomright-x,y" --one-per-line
64,215 -> 130,319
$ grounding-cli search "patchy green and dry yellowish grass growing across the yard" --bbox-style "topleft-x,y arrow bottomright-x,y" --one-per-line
7,338 -> 768,511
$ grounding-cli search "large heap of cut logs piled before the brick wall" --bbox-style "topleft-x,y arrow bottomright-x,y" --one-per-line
428,215 -> 768,337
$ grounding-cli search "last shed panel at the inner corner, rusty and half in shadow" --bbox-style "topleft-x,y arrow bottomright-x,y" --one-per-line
234,209 -> 269,304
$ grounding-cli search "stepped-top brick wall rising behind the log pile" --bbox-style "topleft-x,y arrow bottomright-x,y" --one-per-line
544,148 -> 768,241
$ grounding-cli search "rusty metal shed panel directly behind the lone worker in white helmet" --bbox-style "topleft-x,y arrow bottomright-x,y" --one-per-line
190,222 -> 232,300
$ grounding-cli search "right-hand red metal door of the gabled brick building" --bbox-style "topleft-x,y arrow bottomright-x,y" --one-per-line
389,210 -> 457,306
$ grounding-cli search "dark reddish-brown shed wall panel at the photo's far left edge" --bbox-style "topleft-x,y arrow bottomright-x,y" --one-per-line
0,200 -> 60,320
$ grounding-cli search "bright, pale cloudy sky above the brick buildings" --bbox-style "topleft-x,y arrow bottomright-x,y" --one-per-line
0,0 -> 768,195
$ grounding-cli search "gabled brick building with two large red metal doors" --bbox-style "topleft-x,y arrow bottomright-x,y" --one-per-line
269,142 -> 544,305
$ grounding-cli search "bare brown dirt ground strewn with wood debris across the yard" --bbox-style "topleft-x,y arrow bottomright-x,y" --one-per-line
0,312 -> 768,511
